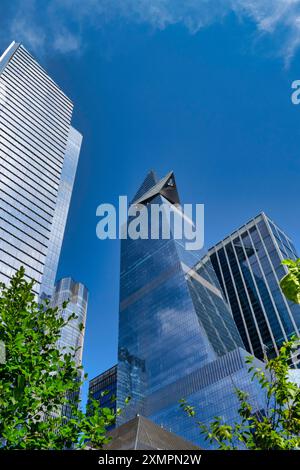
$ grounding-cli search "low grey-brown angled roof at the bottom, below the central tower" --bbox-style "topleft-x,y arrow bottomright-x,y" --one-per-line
105,415 -> 200,450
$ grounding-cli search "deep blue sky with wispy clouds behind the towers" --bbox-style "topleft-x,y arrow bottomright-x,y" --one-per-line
0,0 -> 300,390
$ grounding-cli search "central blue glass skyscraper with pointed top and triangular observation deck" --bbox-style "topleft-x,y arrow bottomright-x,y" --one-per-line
117,172 -> 265,448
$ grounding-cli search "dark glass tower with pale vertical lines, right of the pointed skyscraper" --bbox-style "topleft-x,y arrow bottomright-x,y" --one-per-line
208,213 -> 300,363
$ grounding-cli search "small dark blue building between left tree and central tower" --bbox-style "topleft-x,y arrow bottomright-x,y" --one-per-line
88,365 -> 117,430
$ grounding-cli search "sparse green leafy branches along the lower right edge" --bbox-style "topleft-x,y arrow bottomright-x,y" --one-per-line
180,259 -> 300,450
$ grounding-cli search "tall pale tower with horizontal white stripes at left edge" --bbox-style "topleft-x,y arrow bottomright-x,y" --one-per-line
0,42 -> 82,296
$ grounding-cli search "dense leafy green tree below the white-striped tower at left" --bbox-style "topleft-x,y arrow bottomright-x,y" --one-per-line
0,268 -> 116,449
